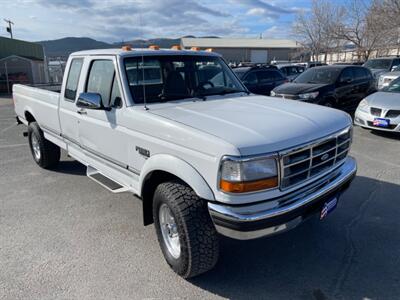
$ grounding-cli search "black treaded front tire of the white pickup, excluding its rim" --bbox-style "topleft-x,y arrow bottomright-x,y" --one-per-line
153,181 -> 219,278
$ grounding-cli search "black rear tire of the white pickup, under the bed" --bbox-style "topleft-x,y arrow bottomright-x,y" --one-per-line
28,122 -> 61,169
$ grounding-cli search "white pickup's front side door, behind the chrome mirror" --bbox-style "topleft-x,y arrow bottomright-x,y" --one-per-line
78,56 -> 131,168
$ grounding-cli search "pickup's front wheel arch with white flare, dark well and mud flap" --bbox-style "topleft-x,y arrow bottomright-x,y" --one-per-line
139,154 -> 214,225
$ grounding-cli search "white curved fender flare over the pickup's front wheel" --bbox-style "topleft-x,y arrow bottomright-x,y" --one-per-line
139,154 -> 215,200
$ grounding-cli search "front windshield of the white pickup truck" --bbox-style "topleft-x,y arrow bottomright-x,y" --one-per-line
125,55 -> 245,103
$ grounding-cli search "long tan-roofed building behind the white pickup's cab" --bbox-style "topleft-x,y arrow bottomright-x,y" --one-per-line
181,38 -> 301,63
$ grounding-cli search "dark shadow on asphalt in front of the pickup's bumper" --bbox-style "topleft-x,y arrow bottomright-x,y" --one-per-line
190,177 -> 400,300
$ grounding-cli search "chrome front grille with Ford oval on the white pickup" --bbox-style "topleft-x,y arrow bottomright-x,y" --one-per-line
280,128 -> 352,190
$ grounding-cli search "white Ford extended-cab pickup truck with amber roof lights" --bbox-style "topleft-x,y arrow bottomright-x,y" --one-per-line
13,47 -> 357,278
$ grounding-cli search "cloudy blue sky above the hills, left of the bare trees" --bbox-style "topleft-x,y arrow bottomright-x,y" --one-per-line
0,0 -> 311,42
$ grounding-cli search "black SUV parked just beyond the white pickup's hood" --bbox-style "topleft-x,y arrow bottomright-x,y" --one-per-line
271,65 -> 376,110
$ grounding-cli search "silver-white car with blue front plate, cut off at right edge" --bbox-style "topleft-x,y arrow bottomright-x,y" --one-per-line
354,78 -> 400,132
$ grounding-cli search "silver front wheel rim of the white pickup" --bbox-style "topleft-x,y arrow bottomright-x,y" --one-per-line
158,204 -> 181,259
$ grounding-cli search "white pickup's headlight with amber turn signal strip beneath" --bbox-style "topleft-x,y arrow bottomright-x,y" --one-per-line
219,157 -> 278,193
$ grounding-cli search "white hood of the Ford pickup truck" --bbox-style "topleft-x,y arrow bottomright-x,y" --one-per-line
150,96 -> 351,155
